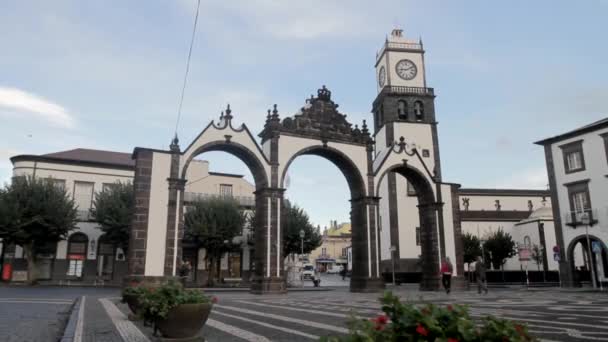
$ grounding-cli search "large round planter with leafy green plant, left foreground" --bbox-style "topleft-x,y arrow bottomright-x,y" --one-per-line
138,281 -> 217,339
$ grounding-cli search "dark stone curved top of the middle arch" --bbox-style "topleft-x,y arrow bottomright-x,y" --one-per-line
279,145 -> 366,199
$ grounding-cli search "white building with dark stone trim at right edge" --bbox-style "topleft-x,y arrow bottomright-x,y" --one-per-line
536,119 -> 608,285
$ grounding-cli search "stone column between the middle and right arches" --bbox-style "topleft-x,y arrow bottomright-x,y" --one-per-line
350,197 -> 384,292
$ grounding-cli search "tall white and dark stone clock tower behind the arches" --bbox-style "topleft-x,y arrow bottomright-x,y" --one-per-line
372,29 -> 443,264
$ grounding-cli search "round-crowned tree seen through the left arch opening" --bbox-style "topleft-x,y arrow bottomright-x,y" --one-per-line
184,197 -> 246,285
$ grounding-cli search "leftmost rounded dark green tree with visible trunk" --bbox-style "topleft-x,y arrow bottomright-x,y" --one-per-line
0,176 -> 77,284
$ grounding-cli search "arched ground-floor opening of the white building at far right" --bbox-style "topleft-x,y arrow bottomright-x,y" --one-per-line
566,235 -> 608,285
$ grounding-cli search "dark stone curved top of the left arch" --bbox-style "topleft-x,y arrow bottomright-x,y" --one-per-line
181,140 -> 269,190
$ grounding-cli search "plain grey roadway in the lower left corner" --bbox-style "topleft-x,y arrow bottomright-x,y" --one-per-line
0,287 -> 117,342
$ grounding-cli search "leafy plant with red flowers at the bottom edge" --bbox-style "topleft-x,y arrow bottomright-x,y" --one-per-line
321,292 -> 538,342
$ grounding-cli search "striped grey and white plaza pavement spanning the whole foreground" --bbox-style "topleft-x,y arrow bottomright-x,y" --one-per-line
0,276 -> 608,341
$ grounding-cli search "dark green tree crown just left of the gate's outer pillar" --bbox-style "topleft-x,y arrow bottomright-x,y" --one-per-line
91,182 -> 135,252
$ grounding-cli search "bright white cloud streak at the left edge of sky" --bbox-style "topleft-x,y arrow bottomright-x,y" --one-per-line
0,87 -> 76,128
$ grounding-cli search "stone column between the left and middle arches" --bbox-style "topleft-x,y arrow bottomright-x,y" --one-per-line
250,188 -> 287,294
